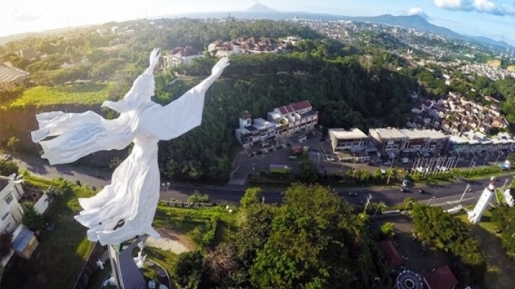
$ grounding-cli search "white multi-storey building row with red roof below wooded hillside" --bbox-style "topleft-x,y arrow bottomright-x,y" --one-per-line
235,100 -> 318,147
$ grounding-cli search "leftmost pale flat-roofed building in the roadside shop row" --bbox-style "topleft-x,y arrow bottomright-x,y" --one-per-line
329,128 -> 369,152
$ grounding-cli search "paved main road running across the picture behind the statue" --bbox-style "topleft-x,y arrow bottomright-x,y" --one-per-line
11,156 -> 508,209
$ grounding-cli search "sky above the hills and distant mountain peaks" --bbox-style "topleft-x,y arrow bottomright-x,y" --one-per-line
0,0 -> 515,45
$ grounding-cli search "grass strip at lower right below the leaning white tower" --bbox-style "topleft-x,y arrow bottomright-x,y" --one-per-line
456,208 -> 515,289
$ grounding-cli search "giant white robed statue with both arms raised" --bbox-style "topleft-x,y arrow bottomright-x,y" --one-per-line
32,49 -> 229,245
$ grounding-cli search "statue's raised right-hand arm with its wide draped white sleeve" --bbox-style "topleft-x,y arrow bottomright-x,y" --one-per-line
140,57 -> 229,140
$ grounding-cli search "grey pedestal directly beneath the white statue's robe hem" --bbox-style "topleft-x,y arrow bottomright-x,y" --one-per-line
107,235 -> 147,289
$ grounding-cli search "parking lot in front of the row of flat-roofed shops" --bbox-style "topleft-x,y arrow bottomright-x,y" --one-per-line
231,131 -> 508,184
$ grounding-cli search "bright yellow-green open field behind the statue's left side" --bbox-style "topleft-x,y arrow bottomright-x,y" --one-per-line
9,83 -> 112,107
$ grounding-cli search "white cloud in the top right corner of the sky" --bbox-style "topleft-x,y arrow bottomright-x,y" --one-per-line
434,0 -> 515,16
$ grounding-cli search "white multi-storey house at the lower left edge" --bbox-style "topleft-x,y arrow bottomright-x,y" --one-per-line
0,175 -> 38,267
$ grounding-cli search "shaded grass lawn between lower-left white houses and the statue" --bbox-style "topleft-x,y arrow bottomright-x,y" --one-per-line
2,177 -> 97,289
